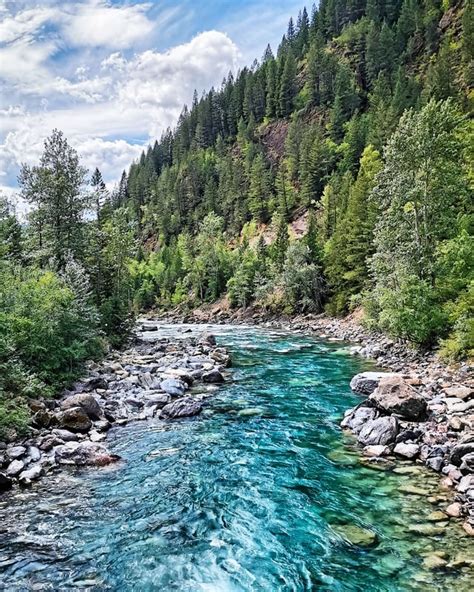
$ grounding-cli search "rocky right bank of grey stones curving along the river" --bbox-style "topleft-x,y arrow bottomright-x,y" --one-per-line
150,305 -> 474,537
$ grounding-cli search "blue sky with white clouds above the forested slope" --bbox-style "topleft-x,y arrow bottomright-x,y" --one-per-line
0,0 -> 303,205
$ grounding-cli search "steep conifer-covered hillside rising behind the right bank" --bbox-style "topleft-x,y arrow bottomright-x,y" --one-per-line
116,0 -> 474,357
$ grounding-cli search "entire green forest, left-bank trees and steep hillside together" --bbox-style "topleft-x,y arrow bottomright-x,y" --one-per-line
0,0 -> 474,435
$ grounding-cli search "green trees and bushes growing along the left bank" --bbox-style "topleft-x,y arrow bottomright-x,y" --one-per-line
0,130 -> 136,438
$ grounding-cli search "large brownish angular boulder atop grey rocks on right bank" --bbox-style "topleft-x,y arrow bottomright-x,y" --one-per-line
369,374 -> 426,421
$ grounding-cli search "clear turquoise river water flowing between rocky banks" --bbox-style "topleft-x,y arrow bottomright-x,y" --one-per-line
0,327 -> 472,592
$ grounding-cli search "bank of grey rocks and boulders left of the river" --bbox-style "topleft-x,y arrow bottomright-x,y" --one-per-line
0,328 -> 230,492
